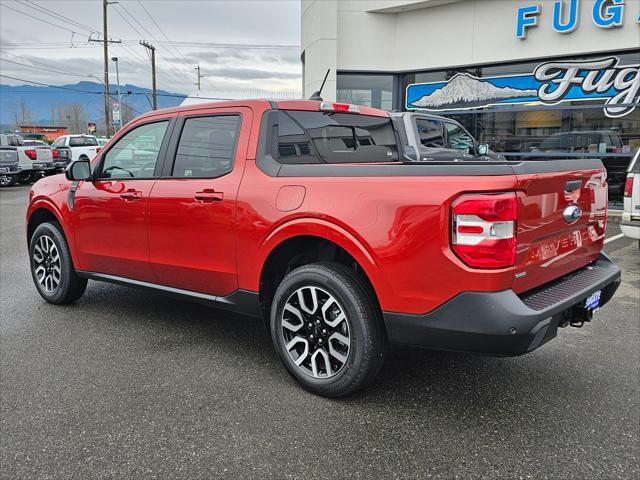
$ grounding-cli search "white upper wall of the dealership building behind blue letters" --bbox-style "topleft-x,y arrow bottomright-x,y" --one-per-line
302,0 -> 640,100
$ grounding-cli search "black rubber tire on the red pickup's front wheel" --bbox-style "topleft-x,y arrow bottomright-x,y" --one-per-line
29,222 -> 87,305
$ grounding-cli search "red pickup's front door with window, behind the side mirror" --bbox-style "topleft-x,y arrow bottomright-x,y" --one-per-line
73,119 -> 170,281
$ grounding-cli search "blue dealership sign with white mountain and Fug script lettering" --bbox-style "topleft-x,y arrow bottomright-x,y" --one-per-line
406,57 -> 640,118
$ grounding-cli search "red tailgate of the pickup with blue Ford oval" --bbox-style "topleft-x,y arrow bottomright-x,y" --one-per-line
512,160 -> 608,293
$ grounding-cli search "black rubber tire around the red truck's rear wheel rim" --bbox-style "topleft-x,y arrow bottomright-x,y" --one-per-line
270,263 -> 386,397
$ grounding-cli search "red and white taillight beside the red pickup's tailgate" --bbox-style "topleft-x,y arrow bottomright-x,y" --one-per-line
451,192 -> 518,268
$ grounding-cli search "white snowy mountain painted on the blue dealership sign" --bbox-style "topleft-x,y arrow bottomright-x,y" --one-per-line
411,73 -> 538,108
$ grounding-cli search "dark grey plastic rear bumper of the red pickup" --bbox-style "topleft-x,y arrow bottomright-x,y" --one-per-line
384,254 -> 620,356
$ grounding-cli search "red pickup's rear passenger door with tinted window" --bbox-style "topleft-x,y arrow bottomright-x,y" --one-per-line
149,108 -> 251,296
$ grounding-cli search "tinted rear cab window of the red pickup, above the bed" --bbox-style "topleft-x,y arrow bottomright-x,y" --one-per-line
274,110 -> 398,164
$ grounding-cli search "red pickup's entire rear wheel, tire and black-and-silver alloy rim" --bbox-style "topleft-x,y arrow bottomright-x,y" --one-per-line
271,263 -> 386,397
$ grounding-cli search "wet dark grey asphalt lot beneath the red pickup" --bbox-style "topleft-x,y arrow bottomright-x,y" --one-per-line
0,187 -> 640,479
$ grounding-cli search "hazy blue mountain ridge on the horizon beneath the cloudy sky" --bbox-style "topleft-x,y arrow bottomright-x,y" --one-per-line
0,82 -> 186,128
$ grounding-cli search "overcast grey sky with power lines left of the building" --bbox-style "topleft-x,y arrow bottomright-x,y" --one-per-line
0,0 -> 302,93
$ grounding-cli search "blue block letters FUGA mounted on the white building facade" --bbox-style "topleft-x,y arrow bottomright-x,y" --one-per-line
516,0 -> 640,39
